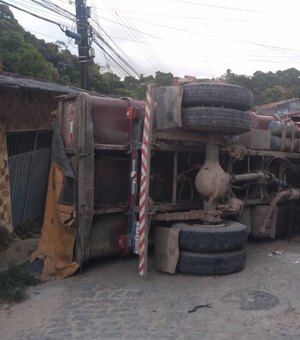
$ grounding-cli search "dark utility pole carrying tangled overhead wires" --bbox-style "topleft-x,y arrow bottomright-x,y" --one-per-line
75,0 -> 91,90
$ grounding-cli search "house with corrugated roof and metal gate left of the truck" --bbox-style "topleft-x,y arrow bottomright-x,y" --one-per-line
0,73 -> 80,232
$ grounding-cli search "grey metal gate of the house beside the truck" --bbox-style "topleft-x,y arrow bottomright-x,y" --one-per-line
7,130 -> 52,228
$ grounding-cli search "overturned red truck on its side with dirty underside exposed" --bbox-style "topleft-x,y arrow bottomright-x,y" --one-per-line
34,82 -> 300,277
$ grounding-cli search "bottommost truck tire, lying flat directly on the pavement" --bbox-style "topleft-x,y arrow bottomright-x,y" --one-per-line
176,249 -> 246,275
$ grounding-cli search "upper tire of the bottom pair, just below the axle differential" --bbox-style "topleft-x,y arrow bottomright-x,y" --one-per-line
173,221 -> 248,252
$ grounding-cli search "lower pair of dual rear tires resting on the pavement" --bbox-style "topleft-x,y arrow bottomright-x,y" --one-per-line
173,221 -> 247,275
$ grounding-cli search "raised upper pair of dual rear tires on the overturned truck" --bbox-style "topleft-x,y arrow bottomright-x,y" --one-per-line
181,83 -> 253,135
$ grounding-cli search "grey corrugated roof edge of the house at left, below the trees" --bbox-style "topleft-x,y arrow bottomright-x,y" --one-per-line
0,74 -> 79,93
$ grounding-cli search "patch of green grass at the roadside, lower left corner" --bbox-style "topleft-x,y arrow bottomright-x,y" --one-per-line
0,266 -> 38,303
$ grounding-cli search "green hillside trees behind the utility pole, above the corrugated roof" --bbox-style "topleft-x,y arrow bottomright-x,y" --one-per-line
0,5 -> 157,99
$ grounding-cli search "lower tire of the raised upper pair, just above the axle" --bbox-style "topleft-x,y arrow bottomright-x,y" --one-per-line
181,107 -> 251,135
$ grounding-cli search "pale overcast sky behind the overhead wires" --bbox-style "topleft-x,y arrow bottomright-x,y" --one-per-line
7,0 -> 300,78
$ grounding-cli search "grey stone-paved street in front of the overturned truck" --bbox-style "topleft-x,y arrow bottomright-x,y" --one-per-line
0,241 -> 300,340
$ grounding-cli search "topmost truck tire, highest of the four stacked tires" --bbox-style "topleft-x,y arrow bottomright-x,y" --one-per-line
182,83 -> 253,111
